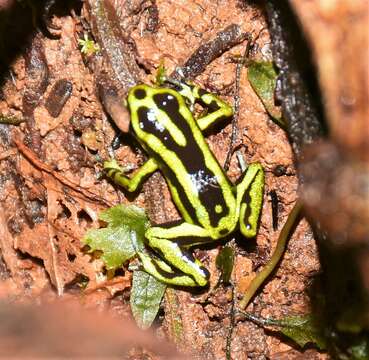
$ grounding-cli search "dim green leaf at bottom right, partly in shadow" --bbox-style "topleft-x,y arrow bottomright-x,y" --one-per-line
273,314 -> 327,350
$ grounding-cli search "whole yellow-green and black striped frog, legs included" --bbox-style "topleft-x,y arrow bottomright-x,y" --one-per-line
104,81 -> 264,287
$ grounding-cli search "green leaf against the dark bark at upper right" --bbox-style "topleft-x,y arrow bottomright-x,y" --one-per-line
247,61 -> 286,129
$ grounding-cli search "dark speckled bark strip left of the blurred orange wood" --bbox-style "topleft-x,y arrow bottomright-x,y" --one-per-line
266,0 -> 327,158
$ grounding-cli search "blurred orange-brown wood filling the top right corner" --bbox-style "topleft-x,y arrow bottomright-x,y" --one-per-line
291,0 -> 369,162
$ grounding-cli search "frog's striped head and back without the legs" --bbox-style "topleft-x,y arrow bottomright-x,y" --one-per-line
128,85 -> 234,228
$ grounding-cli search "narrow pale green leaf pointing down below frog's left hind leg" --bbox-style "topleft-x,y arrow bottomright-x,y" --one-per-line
130,271 -> 166,329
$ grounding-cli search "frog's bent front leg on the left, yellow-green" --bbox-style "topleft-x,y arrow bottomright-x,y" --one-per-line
104,158 -> 158,192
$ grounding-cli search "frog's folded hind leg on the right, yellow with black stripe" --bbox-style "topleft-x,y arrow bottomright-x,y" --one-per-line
236,163 -> 264,237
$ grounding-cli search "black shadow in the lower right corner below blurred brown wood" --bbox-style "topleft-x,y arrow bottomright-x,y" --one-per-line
309,228 -> 369,359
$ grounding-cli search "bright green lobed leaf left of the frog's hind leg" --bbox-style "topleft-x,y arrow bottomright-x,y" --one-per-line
82,204 -> 149,270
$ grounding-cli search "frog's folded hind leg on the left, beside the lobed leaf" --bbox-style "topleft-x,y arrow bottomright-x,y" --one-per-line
139,222 -> 212,286
